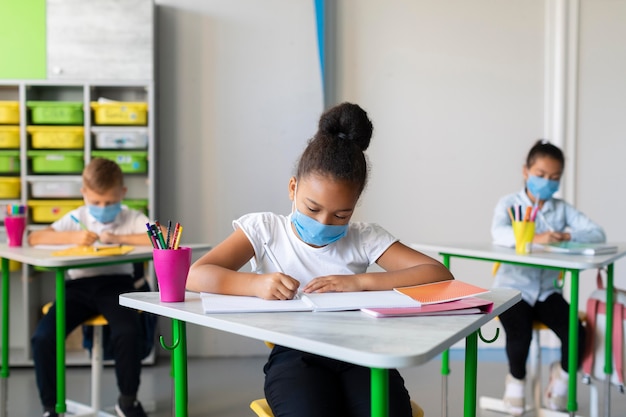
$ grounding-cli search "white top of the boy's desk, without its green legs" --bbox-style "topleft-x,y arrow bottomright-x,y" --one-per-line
0,243 -> 211,268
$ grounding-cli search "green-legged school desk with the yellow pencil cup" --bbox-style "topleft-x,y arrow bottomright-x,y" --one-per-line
411,243 -> 626,416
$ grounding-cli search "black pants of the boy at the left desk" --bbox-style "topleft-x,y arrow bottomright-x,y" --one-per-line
31,275 -> 143,407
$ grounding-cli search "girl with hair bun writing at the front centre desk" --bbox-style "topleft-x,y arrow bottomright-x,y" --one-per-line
187,103 -> 453,417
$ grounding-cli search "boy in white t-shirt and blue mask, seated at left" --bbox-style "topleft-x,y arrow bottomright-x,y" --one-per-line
28,158 -> 151,417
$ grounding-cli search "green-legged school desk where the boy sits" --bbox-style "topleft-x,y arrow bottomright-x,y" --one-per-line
0,244 -> 210,416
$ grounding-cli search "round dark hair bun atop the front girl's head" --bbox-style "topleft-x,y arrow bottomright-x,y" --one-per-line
318,103 -> 374,151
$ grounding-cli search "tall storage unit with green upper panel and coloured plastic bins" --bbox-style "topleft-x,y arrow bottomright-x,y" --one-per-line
0,0 -> 157,366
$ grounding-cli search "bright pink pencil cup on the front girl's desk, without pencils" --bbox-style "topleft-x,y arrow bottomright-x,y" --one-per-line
152,247 -> 191,303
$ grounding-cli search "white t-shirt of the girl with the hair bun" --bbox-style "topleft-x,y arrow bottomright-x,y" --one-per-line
233,213 -> 398,287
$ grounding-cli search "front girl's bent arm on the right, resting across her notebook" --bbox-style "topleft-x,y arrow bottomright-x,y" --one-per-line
303,242 -> 454,292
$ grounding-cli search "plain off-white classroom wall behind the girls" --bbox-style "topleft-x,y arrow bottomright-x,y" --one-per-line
152,0 -> 626,354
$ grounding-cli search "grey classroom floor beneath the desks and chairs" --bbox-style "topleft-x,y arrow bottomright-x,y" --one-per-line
8,349 -> 626,417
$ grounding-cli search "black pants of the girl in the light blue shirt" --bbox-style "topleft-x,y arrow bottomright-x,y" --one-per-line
500,293 -> 585,379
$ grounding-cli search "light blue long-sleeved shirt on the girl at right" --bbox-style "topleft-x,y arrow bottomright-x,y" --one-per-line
491,189 -> 606,306
